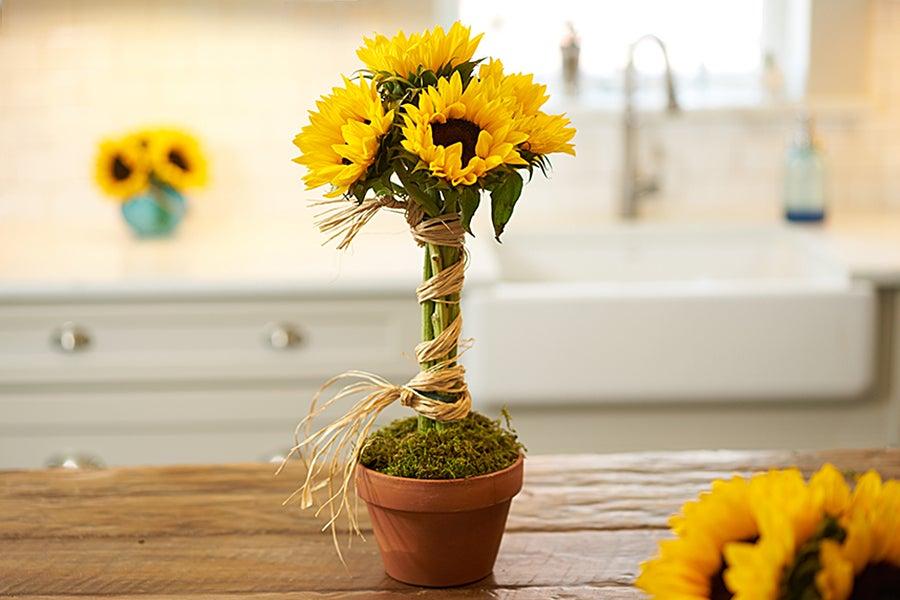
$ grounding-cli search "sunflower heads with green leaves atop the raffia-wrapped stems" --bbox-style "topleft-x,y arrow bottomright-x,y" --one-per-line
294,23 -> 575,238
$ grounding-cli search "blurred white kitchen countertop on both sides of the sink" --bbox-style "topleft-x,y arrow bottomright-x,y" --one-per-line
0,213 -> 900,301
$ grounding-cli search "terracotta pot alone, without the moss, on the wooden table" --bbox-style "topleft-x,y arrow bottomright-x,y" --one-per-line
356,456 -> 524,587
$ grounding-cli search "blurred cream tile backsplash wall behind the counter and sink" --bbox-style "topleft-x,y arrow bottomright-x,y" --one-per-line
0,0 -> 900,230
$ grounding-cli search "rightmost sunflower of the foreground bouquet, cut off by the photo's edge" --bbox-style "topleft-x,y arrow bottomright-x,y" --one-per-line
816,471 -> 900,600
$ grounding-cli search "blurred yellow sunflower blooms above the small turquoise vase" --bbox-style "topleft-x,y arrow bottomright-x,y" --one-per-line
94,128 -> 207,201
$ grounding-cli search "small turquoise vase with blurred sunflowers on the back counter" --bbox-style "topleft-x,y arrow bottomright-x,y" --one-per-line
94,128 -> 206,236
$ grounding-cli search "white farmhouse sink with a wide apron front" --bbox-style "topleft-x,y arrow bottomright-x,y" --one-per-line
465,225 -> 875,404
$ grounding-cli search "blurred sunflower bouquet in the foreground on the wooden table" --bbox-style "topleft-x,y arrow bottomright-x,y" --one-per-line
637,465 -> 900,600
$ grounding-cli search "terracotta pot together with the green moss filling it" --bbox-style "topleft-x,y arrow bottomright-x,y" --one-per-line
356,413 -> 523,587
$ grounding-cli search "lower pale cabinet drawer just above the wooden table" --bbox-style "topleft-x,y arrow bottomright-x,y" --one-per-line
0,386 -> 412,469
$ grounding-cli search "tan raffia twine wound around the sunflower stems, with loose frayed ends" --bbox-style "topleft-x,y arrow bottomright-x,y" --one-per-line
276,197 -> 472,563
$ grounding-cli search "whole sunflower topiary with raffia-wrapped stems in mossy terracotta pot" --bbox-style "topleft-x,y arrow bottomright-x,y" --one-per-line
286,23 -> 575,586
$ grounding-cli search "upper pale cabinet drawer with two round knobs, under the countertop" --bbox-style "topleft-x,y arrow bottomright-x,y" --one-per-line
0,299 -> 418,386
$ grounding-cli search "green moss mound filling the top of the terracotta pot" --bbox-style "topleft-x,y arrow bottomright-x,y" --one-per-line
360,410 -> 524,479
